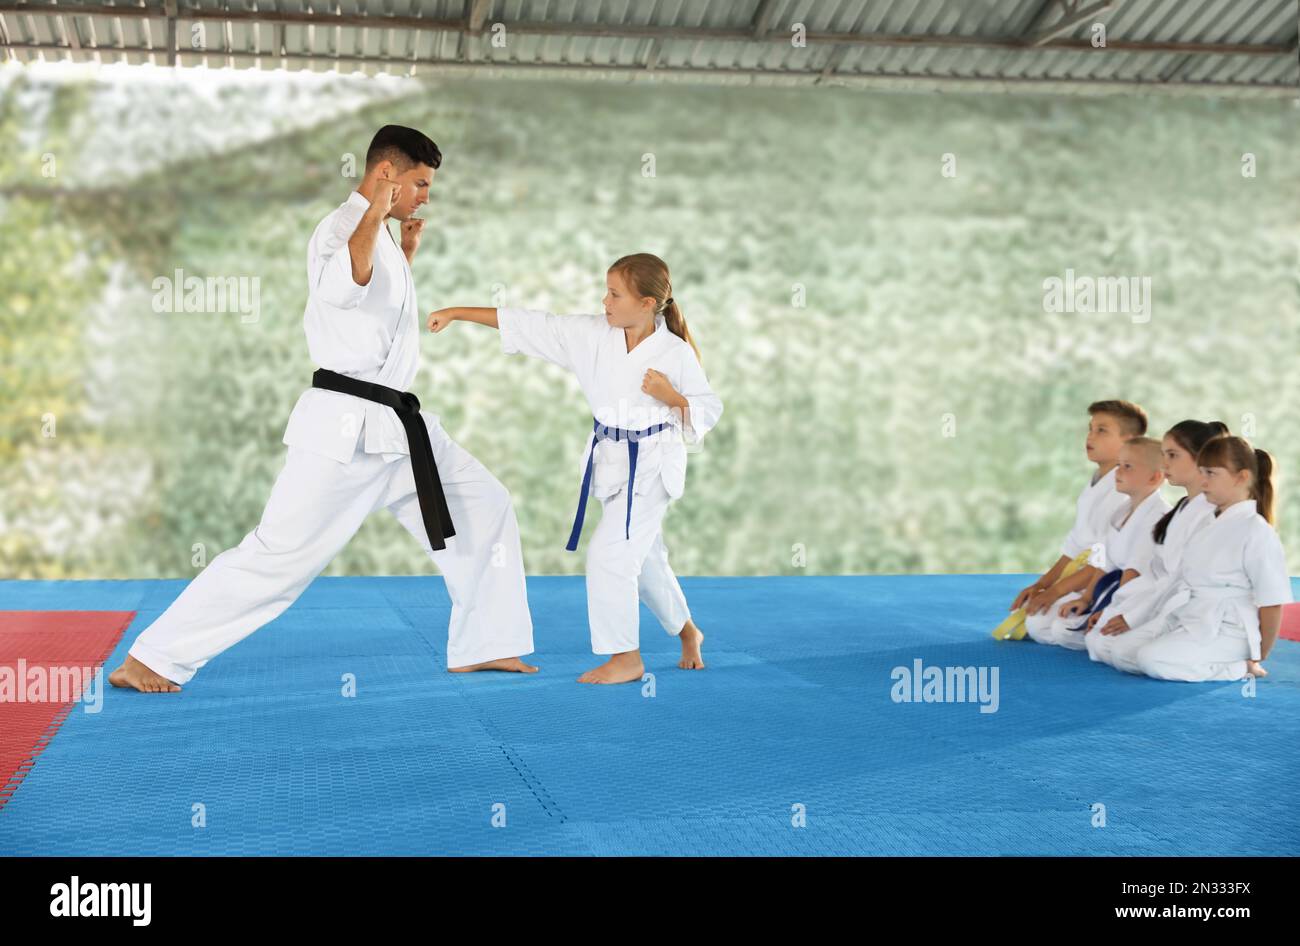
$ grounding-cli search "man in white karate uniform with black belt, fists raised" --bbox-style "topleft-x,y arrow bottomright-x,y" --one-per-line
109,125 -> 537,693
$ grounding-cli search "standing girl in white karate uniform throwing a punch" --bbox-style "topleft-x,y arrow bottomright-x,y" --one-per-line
429,253 -> 723,684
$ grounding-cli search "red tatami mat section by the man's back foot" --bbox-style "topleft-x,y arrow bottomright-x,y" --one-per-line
0,611 -> 135,807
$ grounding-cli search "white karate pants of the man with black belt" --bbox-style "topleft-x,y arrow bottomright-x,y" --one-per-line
130,418 -> 533,684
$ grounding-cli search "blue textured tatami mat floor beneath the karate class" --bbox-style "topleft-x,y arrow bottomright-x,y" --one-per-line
0,576 -> 1300,855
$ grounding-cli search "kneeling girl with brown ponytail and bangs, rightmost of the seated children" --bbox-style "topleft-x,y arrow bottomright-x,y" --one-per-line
1138,437 -> 1291,682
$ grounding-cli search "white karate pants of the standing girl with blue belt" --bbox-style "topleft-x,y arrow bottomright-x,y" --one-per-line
586,477 -> 690,654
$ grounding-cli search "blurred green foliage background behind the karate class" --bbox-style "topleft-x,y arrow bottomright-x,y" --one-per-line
0,68 -> 1300,578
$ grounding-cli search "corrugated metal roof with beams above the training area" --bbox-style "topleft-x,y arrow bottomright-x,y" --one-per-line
0,0 -> 1300,95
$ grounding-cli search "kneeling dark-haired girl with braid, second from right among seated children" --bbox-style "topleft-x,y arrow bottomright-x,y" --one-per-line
1084,420 -> 1229,673
